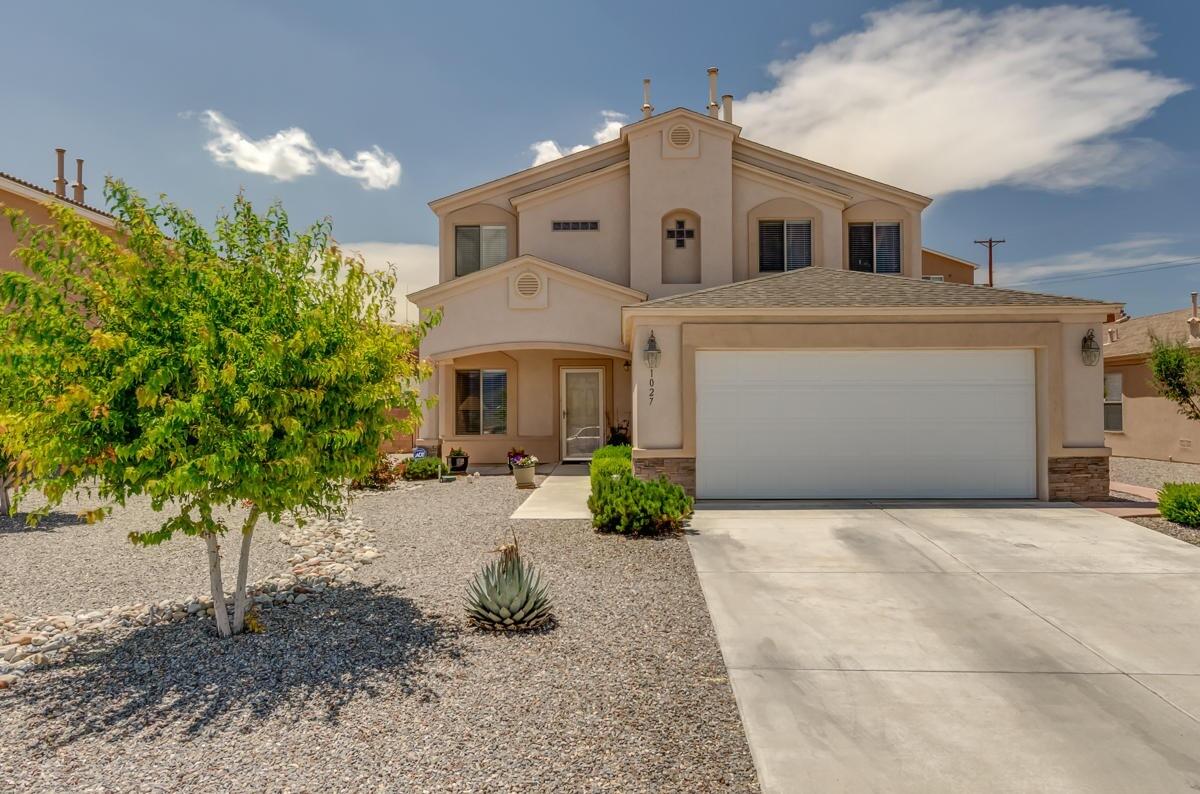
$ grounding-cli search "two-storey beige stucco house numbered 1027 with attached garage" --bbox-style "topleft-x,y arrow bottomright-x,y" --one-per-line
409,72 -> 1120,499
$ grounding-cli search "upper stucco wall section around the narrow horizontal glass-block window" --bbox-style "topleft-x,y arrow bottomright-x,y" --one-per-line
518,169 -> 629,287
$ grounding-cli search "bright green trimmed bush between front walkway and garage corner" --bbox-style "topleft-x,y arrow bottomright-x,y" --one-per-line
588,446 -> 692,535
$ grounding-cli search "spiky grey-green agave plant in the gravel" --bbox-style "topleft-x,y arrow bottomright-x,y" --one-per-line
467,535 -> 551,631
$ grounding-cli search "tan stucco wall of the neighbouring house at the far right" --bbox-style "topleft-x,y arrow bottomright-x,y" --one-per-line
1104,360 -> 1200,463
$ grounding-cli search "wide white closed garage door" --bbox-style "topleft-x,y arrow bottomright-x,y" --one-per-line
696,350 -> 1037,499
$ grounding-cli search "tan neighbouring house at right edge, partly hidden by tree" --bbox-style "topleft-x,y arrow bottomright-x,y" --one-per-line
1104,303 -> 1200,463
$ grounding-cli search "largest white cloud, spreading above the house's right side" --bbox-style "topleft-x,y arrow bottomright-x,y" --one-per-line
738,4 -> 1188,194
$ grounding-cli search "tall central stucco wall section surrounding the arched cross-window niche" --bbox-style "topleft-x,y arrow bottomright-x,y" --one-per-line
628,119 -> 733,297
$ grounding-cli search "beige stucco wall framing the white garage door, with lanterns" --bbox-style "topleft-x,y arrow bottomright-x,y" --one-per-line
630,314 -> 1109,499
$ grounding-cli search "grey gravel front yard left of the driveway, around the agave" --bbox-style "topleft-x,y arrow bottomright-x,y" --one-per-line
0,477 -> 757,792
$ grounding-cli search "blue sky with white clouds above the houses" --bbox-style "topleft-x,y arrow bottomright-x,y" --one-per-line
0,0 -> 1200,314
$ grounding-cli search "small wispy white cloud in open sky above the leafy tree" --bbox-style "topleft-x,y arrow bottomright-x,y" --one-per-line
200,110 -> 400,191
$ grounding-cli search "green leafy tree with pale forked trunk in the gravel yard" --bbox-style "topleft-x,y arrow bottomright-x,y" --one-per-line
0,181 -> 437,637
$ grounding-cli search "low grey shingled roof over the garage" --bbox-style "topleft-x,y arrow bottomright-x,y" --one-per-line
632,267 -> 1115,309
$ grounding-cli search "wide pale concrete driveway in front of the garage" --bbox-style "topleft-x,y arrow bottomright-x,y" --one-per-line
689,503 -> 1200,793
